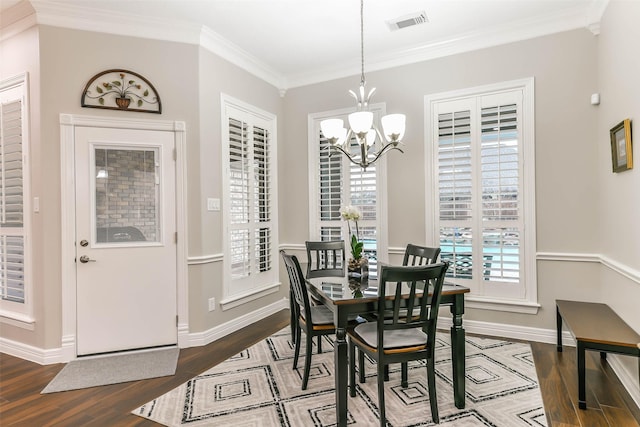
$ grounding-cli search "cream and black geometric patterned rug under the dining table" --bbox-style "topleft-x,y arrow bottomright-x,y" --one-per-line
132,327 -> 547,427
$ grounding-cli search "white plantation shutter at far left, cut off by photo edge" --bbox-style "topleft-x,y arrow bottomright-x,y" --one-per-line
0,99 -> 25,303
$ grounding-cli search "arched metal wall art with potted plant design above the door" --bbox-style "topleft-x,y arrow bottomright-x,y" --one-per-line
81,70 -> 162,114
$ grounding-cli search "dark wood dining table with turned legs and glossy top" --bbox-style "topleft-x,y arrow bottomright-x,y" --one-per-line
303,266 -> 469,426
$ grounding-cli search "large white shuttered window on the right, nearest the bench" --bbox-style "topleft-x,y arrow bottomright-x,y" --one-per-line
425,78 -> 539,313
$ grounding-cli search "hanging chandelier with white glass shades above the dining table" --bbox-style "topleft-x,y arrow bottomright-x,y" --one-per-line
320,0 -> 405,170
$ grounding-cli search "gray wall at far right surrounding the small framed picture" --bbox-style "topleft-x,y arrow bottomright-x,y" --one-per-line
590,1 -> 640,384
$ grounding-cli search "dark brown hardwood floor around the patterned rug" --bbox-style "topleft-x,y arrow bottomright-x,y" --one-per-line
0,310 -> 640,427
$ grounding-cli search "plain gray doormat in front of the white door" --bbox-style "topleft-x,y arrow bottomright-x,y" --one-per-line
41,347 -> 180,394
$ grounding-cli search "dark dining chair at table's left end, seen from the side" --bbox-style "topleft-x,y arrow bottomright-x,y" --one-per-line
280,250 -> 335,390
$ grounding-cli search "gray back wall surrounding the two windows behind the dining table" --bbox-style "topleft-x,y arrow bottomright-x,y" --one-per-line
280,29 -> 599,328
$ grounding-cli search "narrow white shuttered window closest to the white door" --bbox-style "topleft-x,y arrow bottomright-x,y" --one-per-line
221,95 -> 279,310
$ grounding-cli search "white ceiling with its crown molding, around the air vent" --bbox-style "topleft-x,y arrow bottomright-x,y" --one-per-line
0,0 -> 608,89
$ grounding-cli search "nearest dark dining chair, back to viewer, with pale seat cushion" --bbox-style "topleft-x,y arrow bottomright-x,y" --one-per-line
347,263 -> 449,426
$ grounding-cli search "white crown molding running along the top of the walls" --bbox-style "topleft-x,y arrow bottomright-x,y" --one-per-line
12,0 -> 609,91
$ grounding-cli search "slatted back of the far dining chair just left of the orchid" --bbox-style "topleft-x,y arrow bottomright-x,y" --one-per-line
305,240 -> 346,279
